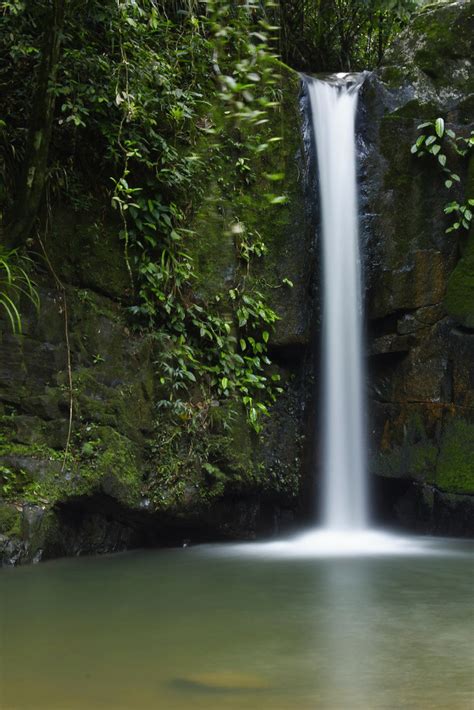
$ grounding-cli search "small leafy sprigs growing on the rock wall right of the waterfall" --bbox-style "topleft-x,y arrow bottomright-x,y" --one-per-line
411,117 -> 474,233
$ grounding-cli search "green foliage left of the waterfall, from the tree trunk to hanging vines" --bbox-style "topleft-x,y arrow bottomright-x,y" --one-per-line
0,0 -> 286,440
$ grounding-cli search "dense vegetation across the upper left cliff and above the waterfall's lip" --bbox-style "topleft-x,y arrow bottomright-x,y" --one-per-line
0,0 -> 424,448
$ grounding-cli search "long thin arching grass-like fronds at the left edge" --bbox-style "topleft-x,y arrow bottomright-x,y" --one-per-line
0,245 -> 39,333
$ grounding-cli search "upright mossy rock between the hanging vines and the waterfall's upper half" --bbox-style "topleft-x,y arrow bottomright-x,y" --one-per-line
187,63 -> 315,347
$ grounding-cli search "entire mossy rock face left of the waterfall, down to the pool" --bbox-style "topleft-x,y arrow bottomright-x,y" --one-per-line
0,62 -> 315,563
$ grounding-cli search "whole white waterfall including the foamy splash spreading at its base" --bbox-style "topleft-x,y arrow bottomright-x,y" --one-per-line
223,79 -> 456,556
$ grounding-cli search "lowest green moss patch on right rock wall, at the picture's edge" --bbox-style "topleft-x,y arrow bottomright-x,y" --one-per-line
436,419 -> 474,493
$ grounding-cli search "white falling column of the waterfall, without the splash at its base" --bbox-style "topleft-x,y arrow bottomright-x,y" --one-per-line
307,75 -> 368,531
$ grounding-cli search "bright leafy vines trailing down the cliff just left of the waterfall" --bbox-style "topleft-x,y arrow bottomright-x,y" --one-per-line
107,2 -> 286,432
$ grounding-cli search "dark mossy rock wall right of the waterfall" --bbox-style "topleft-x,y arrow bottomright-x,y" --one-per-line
360,1 -> 474,535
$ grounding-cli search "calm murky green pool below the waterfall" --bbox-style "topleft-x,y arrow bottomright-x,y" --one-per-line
0,543 -> 474,710
